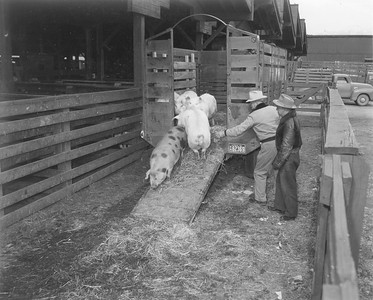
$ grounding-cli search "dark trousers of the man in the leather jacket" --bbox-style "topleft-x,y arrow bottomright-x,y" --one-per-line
274,151 -> 300,217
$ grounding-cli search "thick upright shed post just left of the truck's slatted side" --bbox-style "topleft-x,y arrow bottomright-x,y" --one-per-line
133,13 -> 145,87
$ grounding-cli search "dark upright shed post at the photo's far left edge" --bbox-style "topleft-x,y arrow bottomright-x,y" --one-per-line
0,0 -> 14,93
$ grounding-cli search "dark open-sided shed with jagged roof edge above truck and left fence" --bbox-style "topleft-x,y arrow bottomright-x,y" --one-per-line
0,0 -> 306,90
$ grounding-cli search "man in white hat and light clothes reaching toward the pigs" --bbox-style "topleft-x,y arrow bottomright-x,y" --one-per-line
215,91 -> 280,205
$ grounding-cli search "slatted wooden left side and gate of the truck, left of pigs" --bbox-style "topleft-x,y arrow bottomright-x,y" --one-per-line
142,29 -> 198,146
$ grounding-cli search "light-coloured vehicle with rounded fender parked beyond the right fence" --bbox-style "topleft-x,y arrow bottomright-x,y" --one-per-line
332,74 -> 373,106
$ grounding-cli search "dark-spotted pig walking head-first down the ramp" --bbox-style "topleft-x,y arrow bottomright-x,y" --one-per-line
145,126 -> 187,189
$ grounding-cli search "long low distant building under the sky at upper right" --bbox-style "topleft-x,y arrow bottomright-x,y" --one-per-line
302,35 -> 373,62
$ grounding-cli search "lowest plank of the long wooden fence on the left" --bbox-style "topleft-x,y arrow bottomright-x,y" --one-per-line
0,151 -> 142,229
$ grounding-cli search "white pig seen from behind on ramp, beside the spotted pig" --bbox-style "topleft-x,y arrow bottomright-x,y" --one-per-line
174,107 -> 211,159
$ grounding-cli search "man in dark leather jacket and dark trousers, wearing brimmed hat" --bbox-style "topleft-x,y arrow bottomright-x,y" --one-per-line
268,94 -> 302,221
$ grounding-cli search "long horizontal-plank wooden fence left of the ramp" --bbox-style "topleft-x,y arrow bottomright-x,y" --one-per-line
0,88 -> 148,228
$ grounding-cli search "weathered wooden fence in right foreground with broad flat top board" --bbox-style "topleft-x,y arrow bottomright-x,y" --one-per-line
311,89 -> 369,300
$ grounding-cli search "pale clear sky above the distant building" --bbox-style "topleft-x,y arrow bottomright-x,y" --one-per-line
290,0 -> 373,35
